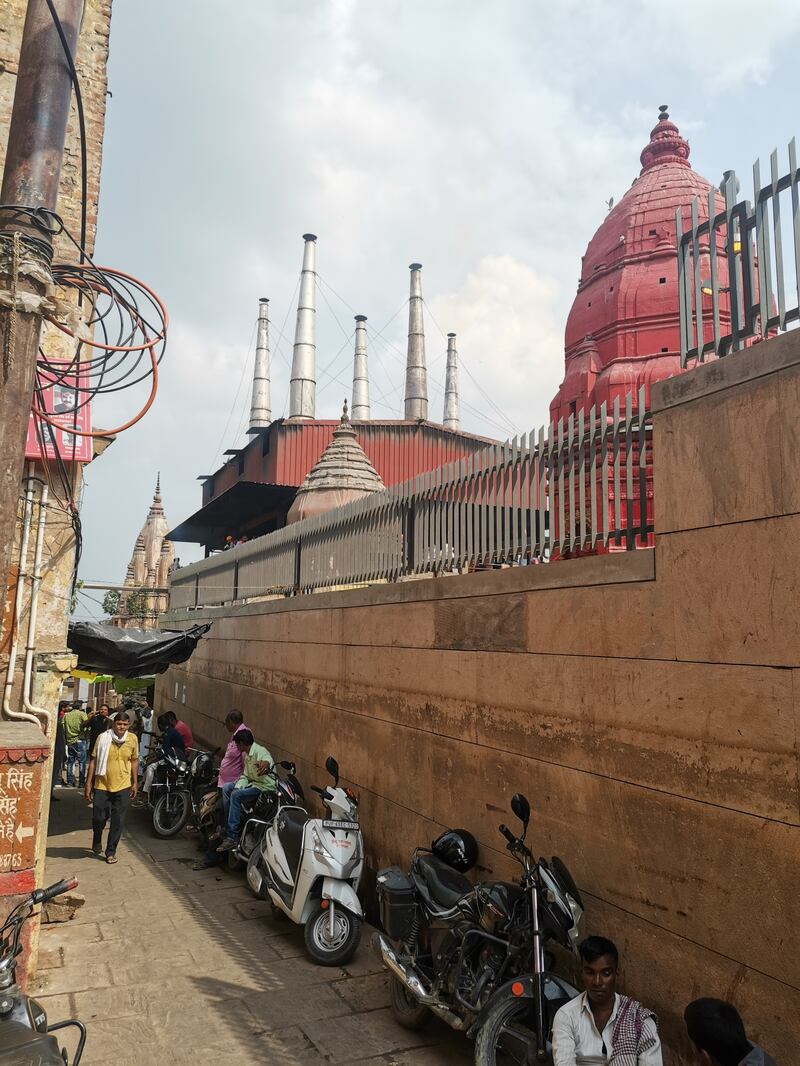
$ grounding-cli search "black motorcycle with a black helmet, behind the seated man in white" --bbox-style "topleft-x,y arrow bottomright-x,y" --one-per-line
372,793 -> 583,1066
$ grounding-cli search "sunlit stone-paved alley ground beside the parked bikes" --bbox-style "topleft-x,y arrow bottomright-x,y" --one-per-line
32,789 -> 473,1066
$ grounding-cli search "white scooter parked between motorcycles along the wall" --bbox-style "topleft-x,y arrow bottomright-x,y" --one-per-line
247,757 -> 364,966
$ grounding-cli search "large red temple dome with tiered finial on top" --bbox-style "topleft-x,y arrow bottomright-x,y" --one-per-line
550,107 -> 729,421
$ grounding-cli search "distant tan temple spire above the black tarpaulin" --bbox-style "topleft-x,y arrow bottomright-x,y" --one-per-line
111,474 -> 175,629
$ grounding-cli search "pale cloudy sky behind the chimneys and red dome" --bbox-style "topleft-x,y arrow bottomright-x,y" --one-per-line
72,0 -> 800,613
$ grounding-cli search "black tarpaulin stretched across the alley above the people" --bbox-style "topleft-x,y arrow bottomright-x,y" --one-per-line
68,621 -> 211,677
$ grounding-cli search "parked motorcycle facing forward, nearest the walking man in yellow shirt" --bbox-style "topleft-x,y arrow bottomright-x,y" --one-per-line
147,752 -> 217,837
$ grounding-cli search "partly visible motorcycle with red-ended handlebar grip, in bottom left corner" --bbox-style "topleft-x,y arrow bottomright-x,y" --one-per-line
0,879 -> 86,1066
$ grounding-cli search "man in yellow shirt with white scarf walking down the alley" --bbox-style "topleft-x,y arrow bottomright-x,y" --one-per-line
85,711 -> 139,862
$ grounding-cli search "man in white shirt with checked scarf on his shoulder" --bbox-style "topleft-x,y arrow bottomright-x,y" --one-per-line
553,936 -> 662,1066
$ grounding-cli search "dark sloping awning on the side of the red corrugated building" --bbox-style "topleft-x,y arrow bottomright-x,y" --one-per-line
166,481 -> 298,548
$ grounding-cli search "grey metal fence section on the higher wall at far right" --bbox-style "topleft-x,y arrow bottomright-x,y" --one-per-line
675,138 -> 800,367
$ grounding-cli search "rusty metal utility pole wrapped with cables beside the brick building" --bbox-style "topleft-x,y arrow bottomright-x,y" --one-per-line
0,0 -> 83,631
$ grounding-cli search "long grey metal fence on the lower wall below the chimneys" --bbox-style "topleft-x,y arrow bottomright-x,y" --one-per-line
170,388 -> 653,609
